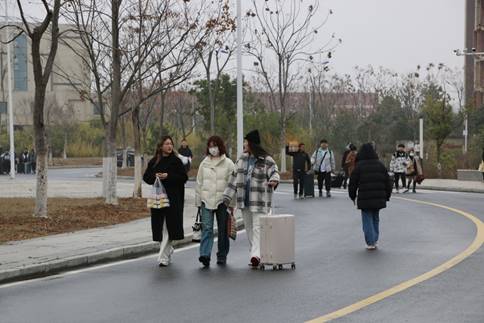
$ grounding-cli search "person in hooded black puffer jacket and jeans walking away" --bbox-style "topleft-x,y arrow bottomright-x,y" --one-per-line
348,144 -> 393,250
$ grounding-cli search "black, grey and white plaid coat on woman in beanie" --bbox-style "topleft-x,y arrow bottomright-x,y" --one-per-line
224,154 -> 280,213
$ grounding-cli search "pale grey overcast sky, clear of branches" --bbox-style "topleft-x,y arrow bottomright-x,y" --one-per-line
0,0 -> 465,74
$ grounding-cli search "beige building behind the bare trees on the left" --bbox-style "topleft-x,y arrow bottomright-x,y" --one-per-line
0,25 -> 95,126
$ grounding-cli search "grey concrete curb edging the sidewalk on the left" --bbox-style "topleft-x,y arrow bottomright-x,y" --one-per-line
0,219 -> 244,285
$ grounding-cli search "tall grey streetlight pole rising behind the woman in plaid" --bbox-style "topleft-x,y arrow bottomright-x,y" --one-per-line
237,0 -> 244,157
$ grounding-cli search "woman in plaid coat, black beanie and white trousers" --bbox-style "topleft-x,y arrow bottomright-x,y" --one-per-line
224,130 -> 280,268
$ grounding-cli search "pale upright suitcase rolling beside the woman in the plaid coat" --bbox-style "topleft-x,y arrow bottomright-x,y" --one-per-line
260,214 -> 296,270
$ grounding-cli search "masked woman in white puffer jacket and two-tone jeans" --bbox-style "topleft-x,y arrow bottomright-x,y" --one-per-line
195,136 -> 235,268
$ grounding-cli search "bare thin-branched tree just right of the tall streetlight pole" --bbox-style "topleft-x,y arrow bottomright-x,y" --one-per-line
246,0 -> 341,172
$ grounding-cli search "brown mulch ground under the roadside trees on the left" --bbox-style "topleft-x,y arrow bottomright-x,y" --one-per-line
0,198 -> 149,244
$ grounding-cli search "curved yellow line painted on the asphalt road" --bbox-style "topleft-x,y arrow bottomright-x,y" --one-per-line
307,197 -> 484,323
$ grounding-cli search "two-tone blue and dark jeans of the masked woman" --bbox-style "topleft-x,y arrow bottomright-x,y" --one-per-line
200,203 -> 230,260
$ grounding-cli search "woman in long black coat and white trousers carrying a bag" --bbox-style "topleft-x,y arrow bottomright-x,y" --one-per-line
143,136 -> 188,267
